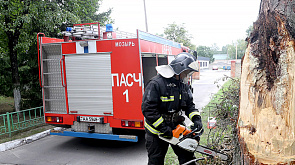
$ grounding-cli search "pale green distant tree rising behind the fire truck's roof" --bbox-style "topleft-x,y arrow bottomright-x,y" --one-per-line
164,22 -> 196,50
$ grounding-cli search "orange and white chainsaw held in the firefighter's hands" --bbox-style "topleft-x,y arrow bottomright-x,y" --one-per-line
159,124 -> 228,161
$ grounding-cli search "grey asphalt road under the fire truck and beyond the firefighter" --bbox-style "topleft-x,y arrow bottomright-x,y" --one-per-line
0,70 -> 230,165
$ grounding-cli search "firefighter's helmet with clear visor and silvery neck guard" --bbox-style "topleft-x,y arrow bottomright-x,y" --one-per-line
156,52 -> 199,78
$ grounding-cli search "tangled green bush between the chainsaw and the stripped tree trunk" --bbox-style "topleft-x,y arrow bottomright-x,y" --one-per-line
202,77 -> 241,164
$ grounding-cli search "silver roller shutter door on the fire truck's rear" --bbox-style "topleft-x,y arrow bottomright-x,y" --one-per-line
65,53 -> 113,115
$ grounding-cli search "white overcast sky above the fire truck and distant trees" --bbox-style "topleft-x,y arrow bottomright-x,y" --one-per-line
100,0 -> 260,49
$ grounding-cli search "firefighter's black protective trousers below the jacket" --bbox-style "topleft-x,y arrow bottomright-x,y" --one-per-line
145,132 -> 194,165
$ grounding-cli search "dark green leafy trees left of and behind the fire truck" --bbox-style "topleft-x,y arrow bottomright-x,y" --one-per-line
0,0 -> 112,111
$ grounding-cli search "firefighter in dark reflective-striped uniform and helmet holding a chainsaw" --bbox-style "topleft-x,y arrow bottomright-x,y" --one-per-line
141,52 -> 203,165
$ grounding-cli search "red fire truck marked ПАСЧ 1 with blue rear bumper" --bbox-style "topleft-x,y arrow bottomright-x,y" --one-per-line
37,23 -> 187,142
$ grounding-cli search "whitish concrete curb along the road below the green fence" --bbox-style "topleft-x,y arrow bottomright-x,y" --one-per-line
0,129 -> 50,152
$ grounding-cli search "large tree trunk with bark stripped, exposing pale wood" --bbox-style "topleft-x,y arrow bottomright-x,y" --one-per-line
238,0 -> 295,164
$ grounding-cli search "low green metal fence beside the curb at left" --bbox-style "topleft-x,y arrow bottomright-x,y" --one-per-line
0,107 -> 45,137
